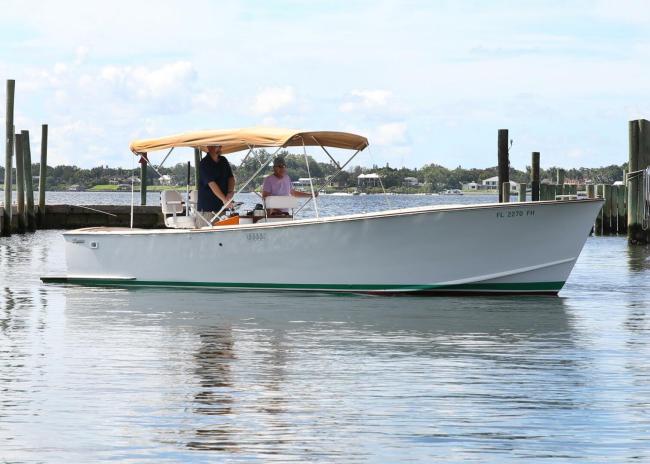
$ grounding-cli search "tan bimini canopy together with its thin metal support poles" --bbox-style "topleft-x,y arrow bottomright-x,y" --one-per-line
130,127 -> 368,227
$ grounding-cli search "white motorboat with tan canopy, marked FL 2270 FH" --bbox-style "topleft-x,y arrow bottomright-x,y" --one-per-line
43,129 -> 602,294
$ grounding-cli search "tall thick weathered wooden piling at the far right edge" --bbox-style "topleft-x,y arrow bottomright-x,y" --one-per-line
627,119 -> 650,243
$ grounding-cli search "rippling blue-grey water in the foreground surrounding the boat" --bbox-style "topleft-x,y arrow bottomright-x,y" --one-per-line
0,197 -> 650,463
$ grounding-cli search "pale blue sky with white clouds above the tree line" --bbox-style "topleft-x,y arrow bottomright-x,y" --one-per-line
0,0 -> 650,169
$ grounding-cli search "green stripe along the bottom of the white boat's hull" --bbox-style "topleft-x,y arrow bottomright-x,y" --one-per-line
41,277 -> 564,293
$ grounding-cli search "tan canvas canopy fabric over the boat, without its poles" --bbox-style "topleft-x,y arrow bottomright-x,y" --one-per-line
130,127 -> 368,154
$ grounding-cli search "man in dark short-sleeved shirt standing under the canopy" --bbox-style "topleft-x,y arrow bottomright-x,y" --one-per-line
198,145 -> 235,213
